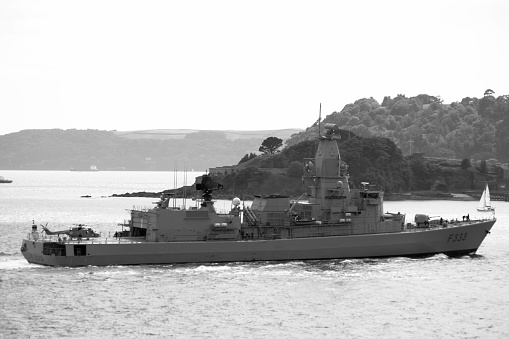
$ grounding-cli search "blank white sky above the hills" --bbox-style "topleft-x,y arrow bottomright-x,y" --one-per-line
0,0 -> 509,135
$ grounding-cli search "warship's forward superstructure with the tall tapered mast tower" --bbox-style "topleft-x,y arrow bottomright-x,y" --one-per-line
244,125 -> 406,239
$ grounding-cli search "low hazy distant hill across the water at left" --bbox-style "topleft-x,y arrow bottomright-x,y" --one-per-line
0,129 -> 302,171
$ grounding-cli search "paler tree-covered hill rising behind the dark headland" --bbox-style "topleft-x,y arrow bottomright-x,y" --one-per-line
287,90 -> 509,162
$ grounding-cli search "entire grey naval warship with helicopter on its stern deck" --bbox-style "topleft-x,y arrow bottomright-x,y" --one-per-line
21,124 -> 496,267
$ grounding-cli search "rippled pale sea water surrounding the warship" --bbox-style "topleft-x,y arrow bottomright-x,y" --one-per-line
0,171 -> 509,338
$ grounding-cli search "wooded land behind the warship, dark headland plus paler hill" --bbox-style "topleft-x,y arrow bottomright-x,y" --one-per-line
211,90 -> 509,195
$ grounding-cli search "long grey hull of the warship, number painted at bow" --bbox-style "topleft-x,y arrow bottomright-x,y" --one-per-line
22,220 -> 495,267
